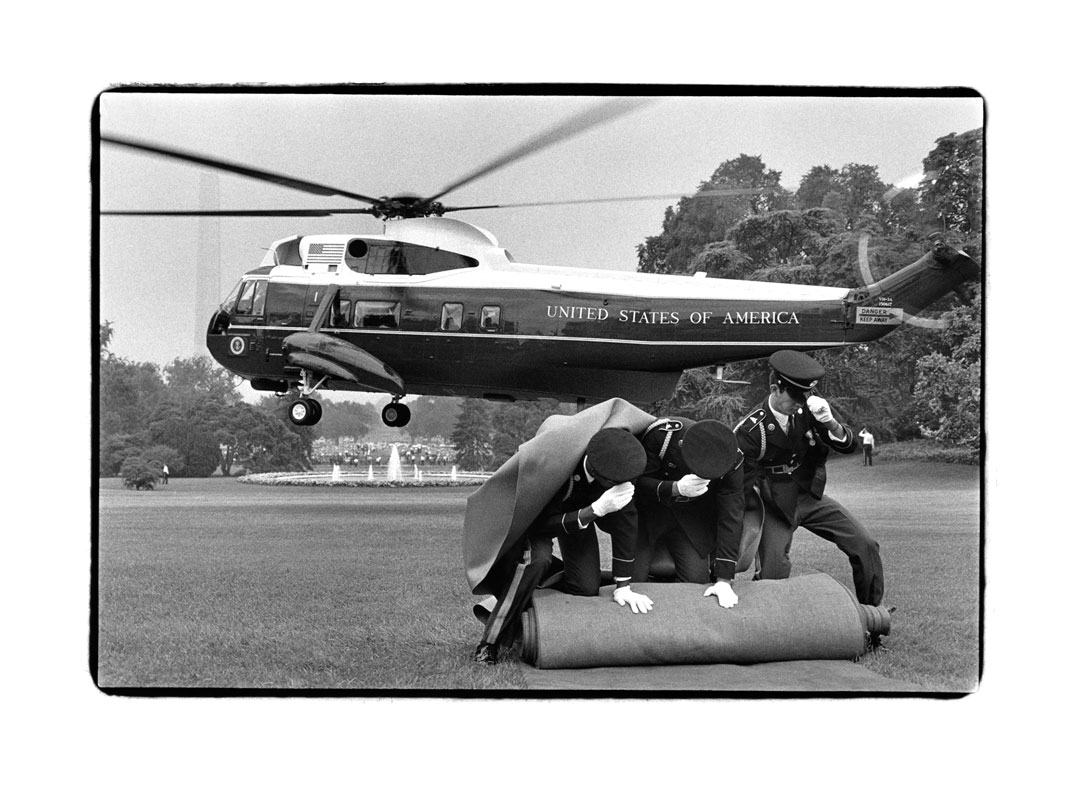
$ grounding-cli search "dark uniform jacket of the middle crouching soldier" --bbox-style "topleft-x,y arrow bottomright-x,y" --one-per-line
634,418 -> 743,580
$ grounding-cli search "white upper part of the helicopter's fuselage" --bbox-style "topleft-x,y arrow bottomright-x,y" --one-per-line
264,217 -> 849,300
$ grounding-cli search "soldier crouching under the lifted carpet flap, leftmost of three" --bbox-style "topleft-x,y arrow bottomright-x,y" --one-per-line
473,428 -> 652,663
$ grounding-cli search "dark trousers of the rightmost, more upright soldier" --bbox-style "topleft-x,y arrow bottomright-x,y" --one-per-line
754,493 -> 885,605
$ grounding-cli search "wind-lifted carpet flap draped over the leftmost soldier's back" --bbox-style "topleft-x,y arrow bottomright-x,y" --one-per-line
462,399 -> 654,594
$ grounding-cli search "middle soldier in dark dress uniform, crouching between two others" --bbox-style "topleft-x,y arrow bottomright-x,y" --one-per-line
634,418 -> 743,607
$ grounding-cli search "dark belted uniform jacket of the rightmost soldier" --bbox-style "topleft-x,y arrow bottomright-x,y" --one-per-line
734,399 -> 860,520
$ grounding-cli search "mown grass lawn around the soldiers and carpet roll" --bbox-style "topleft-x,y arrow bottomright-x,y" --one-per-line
96,457 -> 980,692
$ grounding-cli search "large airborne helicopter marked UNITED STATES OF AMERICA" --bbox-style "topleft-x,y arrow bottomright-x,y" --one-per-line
100,100 -> 981,427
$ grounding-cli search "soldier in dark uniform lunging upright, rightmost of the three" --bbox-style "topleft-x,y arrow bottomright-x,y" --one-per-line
735,349 -> 885,605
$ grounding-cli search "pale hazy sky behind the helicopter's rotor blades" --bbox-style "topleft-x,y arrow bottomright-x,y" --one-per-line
98,89 -> 983,365
